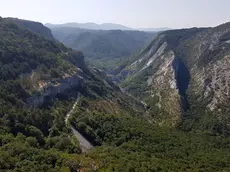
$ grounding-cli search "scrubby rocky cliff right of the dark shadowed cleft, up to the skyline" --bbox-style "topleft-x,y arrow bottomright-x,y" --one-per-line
181,23 -> 230,125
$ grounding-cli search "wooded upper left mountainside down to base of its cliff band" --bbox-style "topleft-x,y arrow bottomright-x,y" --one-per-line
0,18 -> 86,107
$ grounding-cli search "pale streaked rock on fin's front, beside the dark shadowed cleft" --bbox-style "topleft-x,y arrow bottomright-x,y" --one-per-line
143,49 -> 180,126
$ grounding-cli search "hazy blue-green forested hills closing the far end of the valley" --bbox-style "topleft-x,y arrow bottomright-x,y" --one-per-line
48,27 -> 156,70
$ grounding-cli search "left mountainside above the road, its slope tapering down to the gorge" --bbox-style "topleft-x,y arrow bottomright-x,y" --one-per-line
0,18 -> 143,117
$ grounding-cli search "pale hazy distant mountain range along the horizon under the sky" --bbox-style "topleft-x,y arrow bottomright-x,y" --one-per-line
45,22 -> 170,32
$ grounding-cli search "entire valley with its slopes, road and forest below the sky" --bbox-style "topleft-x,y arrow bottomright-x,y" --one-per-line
0,15 -> 230,172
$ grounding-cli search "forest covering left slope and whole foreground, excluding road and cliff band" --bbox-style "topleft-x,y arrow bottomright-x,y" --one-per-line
0,18 -> 230,172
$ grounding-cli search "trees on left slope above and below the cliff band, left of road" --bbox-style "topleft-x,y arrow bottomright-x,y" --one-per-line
0,18 -> 90,171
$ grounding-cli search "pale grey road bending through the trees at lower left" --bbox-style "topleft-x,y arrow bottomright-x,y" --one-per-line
65,93 -> 93,152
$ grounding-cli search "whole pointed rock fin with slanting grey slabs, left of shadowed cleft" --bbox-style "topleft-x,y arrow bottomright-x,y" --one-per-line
120,39 -> 182,126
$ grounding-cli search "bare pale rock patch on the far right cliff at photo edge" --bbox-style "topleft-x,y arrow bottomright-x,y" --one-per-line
192,55 -> 230,111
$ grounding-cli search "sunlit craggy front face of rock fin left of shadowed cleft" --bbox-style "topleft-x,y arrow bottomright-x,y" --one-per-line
147,51 -> 182,126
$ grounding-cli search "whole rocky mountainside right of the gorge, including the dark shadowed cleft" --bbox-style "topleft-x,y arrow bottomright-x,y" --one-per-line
120,23 -> 230,130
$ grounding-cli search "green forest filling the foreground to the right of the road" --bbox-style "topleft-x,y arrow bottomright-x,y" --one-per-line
68,99 -> 230,172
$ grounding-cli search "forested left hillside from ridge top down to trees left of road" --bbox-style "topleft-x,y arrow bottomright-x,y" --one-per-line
0,18 -> 143,171
